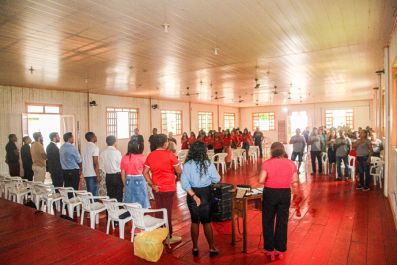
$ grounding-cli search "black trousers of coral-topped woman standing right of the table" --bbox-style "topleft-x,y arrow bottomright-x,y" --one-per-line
262,188 -> 291,252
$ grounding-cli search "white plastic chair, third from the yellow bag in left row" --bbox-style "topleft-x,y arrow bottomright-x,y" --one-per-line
76,191 -> 109,229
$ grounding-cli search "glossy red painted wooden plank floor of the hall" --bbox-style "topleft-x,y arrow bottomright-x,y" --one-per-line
0,158 -> 397,265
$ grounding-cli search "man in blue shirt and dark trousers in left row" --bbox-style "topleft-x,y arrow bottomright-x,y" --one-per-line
59,132 -> 81,190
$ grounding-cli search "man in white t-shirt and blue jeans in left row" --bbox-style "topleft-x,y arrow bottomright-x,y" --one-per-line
82,132 -> 101,196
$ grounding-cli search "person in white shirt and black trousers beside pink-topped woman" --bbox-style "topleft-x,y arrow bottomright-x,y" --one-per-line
99,135 -> 123,202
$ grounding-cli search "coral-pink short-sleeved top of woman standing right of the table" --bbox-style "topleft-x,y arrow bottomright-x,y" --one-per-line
262,158 -> 296,189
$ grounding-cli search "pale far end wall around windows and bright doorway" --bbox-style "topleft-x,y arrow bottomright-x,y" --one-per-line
240,100 -> 374,141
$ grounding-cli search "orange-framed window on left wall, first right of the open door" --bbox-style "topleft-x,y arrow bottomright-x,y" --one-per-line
106,108 -> 138,139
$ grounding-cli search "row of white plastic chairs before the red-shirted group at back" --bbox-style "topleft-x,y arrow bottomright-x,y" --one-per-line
177,146 -> 259,174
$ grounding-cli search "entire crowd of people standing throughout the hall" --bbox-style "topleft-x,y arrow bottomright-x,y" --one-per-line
6,123 -> 383,260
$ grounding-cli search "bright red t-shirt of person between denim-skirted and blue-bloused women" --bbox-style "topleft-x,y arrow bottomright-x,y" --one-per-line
145,149 -> 179,192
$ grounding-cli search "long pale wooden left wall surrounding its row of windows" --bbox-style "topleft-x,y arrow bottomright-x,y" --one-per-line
0,86 -> 239,173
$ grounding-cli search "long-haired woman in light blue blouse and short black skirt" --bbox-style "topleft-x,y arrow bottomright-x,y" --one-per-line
181,142 -> 220,257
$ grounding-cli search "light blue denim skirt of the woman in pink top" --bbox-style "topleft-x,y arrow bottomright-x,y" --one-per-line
124,175 -> 150,208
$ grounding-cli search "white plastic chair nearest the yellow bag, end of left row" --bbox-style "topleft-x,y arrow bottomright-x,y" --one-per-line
125,203 -> 170,247
